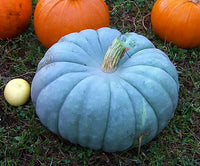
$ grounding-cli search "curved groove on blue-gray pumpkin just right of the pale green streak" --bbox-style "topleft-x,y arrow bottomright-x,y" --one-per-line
119,76 -> 160,135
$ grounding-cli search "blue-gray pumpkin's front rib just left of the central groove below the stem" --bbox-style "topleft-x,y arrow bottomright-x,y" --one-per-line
74,74 -> 110,149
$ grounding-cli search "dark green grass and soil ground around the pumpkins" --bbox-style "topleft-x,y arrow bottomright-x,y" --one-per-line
0,0 -> 200,166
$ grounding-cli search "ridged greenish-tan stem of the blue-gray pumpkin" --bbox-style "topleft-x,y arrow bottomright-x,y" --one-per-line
101,37 -> 126,73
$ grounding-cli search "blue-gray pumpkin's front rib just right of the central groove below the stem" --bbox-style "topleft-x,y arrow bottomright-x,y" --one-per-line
104,79 -> 135,152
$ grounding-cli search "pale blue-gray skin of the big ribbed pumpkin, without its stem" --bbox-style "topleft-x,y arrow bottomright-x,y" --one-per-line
31,28 -> 179,152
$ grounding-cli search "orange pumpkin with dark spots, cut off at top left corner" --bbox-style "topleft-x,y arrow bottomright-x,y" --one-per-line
0,0 -> 32,39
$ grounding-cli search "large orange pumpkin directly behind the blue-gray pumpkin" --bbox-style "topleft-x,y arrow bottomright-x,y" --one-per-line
34,0 -> 109,48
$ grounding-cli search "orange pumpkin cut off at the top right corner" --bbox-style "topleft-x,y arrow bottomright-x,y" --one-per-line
151,0 -> 200,48
